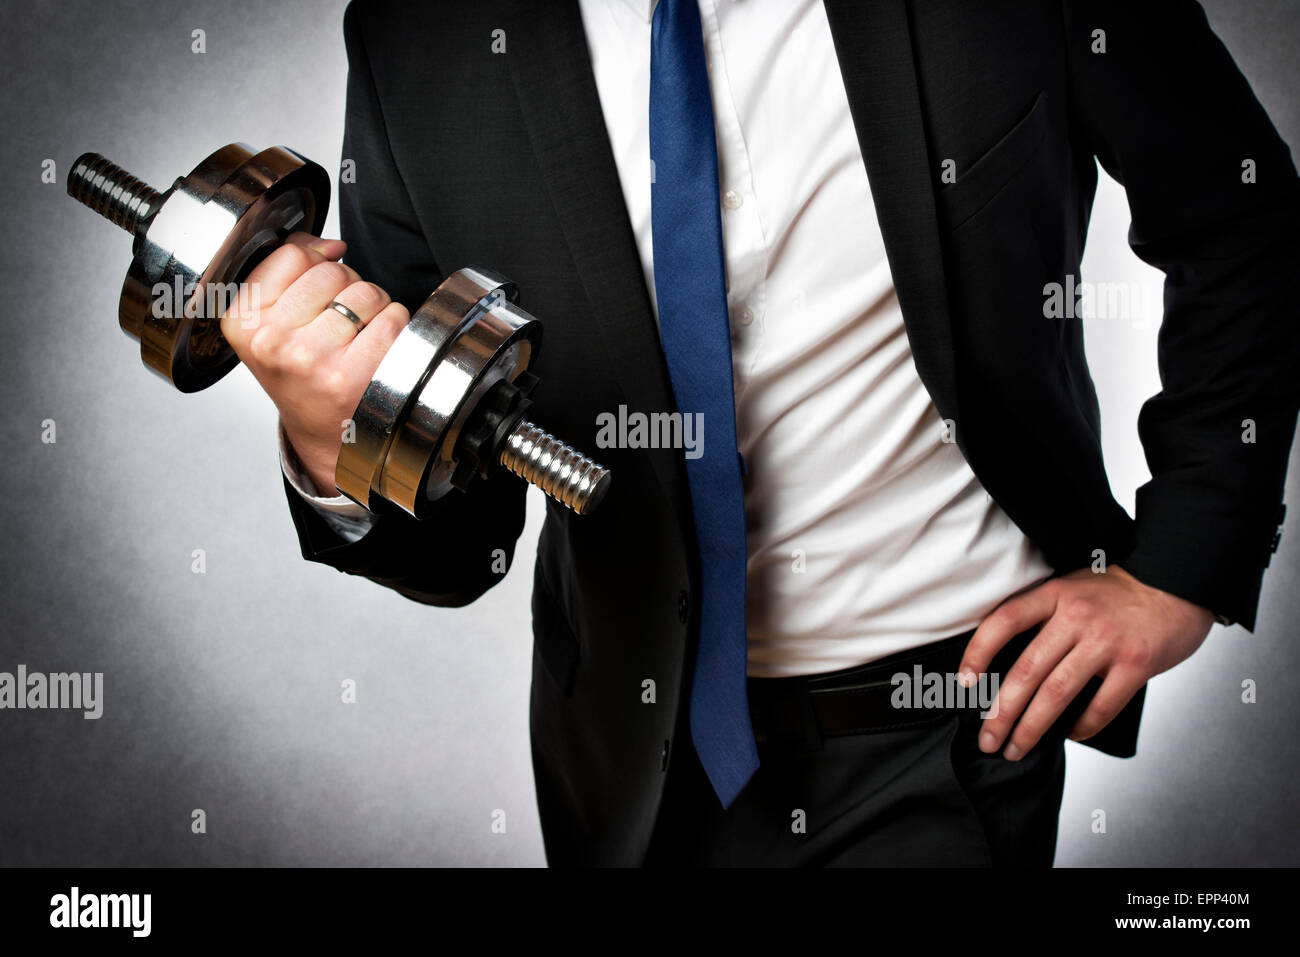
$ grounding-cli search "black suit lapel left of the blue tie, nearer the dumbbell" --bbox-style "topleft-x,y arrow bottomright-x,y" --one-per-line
493,0 -> 684,514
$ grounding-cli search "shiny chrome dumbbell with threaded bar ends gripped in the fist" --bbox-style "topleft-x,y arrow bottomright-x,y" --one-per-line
68,143 -> 610,518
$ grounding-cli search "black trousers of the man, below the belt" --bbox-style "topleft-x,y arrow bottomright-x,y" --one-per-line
645,632 -> 1071,867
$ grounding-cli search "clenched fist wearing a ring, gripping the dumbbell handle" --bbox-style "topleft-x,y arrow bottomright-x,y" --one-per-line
221,233 -> 411,495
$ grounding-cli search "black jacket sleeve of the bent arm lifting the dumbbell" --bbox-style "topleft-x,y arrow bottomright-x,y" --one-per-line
285,4 -> 527,606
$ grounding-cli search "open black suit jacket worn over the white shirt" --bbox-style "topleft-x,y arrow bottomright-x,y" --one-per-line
286,0 -> 1300,863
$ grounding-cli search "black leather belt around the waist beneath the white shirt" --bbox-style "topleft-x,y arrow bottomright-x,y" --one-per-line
748,628 -> 1037,748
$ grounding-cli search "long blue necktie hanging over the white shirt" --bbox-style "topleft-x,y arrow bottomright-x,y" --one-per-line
650,0 -> 758,807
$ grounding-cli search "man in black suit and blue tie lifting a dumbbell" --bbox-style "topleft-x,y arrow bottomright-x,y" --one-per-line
224,0 -> 1300,865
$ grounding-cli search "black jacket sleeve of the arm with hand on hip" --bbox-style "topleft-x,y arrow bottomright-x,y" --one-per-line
1062,0 -> 1300,629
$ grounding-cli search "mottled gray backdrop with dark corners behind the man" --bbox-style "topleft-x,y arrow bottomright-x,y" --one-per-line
0,0 -> 1300,865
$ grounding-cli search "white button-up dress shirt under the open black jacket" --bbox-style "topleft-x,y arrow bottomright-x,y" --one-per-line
283,0 -> 1052,676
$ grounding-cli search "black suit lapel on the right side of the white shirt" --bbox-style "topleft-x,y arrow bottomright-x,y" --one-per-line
824,0 -> 961,426
